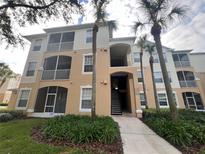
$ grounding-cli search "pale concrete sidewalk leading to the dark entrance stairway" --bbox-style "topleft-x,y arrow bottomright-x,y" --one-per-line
113,116 -> 181,154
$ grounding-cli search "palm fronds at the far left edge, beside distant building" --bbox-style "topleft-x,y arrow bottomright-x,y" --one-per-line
0,63 -> 15,88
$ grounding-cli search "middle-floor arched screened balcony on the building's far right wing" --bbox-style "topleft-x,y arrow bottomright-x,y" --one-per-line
177,71 -> 197,87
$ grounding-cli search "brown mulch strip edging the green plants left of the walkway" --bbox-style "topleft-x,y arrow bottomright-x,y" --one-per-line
31,126 -> 123,154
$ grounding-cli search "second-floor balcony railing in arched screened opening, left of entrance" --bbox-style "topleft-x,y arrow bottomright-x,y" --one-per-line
41,69 -> 70,80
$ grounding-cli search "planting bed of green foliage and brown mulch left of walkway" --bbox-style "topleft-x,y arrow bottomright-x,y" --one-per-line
32,115 -> 123,154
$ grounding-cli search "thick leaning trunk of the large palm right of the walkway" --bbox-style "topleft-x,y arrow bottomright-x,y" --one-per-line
153,33 -> 178,120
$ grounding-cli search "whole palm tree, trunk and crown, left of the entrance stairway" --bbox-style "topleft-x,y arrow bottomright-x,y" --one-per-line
91,0 -> 113,119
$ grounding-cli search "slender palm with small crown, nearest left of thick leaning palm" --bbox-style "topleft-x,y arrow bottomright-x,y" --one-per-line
146,44 -> 160,112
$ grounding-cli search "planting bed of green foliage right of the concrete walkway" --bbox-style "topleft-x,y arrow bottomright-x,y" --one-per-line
142,110 -> 205,153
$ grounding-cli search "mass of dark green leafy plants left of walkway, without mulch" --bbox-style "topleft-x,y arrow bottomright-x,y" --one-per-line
43,115 -> 119,143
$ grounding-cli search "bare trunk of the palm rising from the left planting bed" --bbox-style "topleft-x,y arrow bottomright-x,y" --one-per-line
91,24 -> 98,120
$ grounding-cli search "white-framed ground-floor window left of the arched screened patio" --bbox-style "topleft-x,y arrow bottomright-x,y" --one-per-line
17,89 -> 30,108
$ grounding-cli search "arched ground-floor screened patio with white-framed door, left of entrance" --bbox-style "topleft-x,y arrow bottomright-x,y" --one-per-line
34,86 -> 67,113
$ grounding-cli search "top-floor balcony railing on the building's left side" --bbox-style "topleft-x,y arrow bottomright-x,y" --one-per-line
47,42 -> 73,52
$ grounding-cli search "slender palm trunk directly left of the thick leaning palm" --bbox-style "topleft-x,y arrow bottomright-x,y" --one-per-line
149,56 -> 160,112
